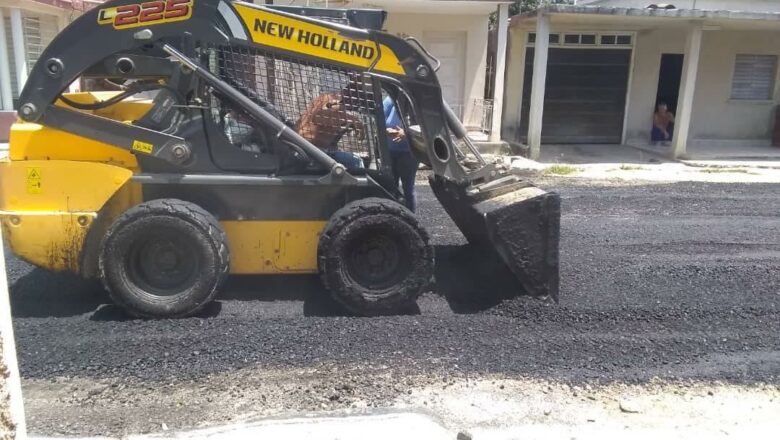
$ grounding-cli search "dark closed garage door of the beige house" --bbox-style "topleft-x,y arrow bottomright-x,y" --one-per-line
521,48 -> 632,144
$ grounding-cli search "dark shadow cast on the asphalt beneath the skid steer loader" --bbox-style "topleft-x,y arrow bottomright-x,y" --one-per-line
10,245 -> 522,321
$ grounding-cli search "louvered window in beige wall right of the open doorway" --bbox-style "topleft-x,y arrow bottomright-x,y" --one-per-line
731,54 -> 777,101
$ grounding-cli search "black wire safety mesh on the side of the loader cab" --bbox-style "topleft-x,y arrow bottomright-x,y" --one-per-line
208,45 -> 381,160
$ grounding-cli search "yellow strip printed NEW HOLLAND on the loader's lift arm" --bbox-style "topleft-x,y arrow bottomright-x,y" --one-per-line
233,3 -> 404,75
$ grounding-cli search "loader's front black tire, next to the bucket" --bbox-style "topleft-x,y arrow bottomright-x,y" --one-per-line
317,198 -> 434,316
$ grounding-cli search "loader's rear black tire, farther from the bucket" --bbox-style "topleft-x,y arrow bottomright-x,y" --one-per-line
98,199 -> 230,318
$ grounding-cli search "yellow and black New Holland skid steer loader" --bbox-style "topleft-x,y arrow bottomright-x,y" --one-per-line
0,0 -> 560,318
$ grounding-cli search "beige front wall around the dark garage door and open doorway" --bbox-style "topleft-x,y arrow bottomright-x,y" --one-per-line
502,19 -> 780,144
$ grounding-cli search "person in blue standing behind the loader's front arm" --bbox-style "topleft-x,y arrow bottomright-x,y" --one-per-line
382,96 -> 419,212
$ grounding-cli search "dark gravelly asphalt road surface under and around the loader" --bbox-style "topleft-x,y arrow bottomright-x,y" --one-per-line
7,178 -> 780,434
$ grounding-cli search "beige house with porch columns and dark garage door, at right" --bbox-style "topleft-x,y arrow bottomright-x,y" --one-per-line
502,0 -> 780,157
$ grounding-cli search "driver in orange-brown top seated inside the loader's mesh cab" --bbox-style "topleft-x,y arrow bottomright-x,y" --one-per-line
295,93 -> 365,169
